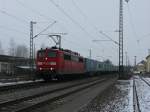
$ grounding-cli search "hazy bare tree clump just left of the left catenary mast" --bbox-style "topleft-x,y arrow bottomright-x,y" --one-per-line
16,45 -> 28,58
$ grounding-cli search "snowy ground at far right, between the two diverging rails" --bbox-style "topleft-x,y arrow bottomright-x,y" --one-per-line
135,77 -> 150,112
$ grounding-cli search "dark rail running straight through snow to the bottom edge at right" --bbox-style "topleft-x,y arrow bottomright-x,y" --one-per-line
133,78 -> 141,112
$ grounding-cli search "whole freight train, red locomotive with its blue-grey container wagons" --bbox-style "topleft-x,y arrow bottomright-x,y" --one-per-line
36,47 -> 118,80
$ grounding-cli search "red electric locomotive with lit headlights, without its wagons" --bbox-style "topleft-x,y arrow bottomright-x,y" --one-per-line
36,47 -> 85,80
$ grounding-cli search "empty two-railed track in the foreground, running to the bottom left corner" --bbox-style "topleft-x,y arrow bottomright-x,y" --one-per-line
0,76 -> 112,112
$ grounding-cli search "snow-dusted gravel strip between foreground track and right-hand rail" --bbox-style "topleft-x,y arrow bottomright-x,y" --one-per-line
79,80 -> 133,112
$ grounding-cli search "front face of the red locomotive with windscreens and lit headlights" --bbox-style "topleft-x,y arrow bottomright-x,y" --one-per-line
36,49 -> 58,80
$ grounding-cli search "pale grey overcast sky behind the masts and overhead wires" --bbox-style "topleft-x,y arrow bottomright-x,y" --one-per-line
0,0 -> 150,64
